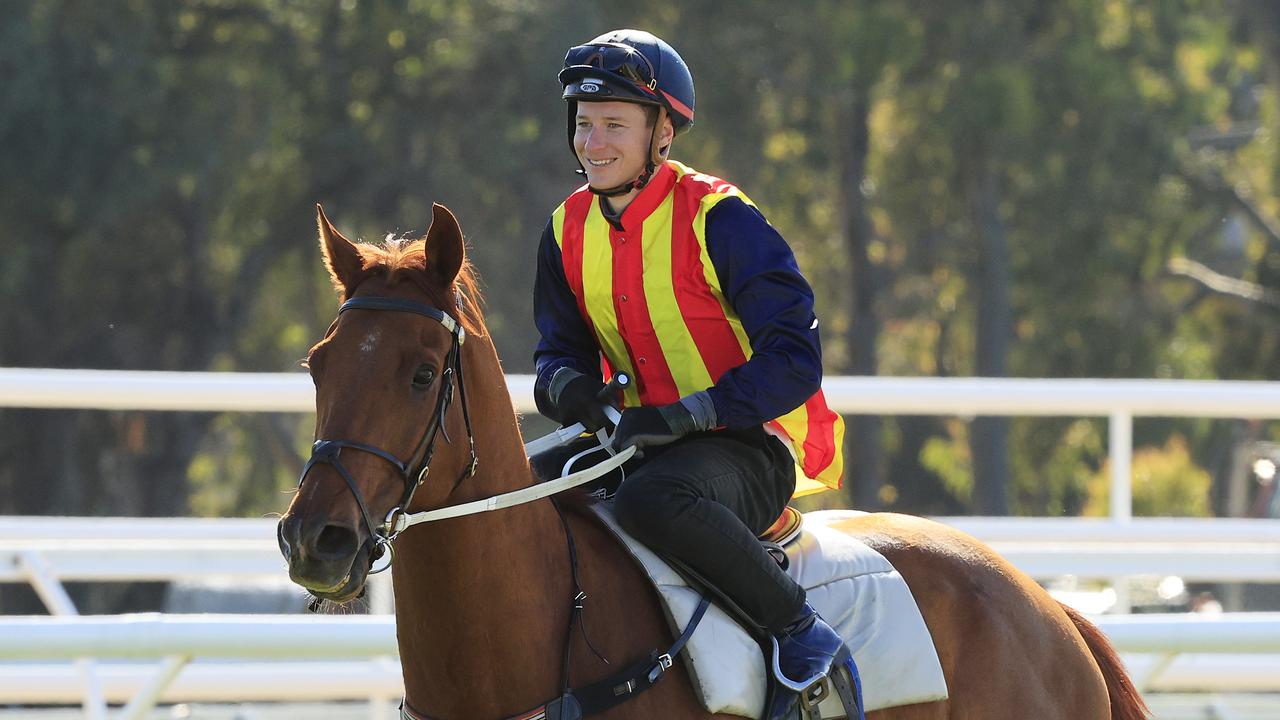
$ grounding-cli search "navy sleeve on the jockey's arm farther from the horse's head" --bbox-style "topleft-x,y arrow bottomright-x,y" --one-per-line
707,197 -> 822,428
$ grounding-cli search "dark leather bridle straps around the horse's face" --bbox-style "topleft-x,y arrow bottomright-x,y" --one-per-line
298,296 -> 476,575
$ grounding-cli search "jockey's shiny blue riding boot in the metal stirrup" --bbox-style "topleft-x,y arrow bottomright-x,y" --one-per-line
767,602 -> 856,720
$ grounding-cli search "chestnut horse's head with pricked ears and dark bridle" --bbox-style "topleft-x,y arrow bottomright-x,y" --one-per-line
278,205 -> 479,602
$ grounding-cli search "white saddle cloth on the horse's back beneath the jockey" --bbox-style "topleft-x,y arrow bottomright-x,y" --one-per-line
594,502 -> 947,717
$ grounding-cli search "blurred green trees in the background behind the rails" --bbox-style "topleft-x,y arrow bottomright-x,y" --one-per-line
0,0 -> 1280,612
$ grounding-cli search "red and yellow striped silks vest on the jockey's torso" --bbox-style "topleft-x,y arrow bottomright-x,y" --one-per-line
552,161 -> 845,488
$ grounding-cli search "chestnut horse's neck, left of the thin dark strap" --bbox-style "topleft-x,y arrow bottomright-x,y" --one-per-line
394,338 -> 573,719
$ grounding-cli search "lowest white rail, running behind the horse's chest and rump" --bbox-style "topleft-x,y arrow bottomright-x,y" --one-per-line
0,612 -> 1280,703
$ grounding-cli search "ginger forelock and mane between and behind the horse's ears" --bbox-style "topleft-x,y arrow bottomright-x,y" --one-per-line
350,234 -> 488,336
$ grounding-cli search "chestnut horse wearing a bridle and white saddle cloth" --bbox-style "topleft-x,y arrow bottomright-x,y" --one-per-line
278,205 -> 1149,720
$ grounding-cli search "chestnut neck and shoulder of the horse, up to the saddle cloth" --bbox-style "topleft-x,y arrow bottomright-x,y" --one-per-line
394,338 -> 704,720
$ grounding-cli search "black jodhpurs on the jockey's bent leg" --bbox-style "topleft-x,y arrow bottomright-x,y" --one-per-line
614,428 -> 805,634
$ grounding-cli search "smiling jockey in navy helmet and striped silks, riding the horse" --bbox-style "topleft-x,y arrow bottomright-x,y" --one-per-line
534,29 -> 849,717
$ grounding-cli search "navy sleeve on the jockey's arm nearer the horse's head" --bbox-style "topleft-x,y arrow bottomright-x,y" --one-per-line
534,222 -> 600,419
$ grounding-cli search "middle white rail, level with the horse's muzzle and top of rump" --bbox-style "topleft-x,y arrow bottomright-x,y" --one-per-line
0,516 -> 1280,583
